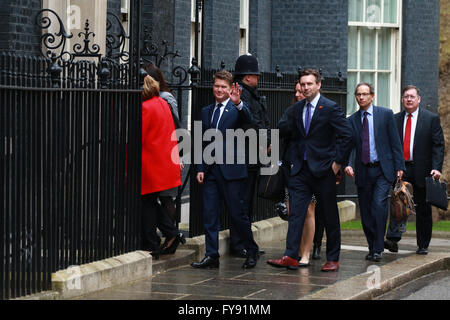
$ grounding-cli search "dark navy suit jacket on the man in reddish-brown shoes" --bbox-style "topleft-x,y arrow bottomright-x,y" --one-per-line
278,95 -> 352,178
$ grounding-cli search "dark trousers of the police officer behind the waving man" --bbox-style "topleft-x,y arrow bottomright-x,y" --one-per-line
230,168 -> 259,252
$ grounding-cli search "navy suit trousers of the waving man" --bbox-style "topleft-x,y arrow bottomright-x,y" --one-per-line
203,165 -> 258,257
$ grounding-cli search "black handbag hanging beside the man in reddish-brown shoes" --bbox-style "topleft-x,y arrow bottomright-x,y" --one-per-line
258,164 -> 285,201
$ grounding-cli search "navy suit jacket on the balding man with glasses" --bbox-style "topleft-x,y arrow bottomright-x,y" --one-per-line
349,106 -> 405,186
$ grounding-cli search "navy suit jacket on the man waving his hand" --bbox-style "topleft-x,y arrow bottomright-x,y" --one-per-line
197,100 -> 253,180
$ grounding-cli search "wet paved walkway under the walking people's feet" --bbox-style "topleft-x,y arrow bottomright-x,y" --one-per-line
74,236 -> 450,301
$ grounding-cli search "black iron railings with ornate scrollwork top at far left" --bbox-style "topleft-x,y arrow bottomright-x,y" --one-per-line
0,1 -> 142,299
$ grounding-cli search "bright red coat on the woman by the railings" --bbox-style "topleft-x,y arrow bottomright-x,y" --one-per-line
141,97 -> 181,194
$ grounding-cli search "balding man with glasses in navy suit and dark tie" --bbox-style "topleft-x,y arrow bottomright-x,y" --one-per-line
345,82 -> 405,262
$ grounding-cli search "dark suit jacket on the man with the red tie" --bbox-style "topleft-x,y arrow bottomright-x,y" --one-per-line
395,107 -> 445,188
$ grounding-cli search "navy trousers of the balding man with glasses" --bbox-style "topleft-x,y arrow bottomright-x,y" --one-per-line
358,166 -> 391,253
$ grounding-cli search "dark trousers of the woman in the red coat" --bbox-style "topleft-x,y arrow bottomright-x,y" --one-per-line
142,192 -> 178,251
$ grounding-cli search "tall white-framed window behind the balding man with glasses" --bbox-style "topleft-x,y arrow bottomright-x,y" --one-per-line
347,0 -> 401,115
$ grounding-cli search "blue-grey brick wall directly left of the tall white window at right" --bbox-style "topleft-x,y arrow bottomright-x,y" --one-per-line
272,0 -> 348,77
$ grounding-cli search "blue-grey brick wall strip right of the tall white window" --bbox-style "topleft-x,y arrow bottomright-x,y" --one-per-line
402,0 -> 440,111
